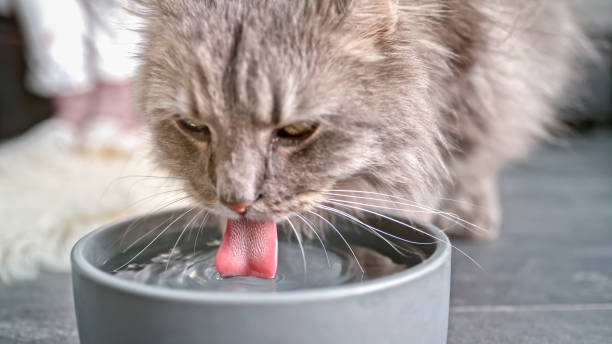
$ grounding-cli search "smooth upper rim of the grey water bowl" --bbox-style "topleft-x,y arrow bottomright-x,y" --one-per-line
70,211 -> 451,305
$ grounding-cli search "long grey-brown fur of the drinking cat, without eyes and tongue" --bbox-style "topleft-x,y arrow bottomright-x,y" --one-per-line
139,0 -> 588,235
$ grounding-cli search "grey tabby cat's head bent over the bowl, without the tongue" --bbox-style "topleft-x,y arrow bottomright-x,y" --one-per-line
139,0 -> 440,218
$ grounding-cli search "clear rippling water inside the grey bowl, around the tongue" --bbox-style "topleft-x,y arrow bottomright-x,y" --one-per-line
102,222 -> 425,292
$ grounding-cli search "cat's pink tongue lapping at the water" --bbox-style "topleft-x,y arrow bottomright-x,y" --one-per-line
215,219 -> 278,278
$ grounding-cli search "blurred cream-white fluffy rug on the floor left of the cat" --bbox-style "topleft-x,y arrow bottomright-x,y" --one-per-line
0,120 -> 182,282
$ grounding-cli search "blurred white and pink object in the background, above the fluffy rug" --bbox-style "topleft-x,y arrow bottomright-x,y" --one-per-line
2,0 -> 140,130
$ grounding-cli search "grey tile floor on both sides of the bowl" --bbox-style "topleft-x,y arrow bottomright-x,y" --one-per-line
0,129 -> 612,344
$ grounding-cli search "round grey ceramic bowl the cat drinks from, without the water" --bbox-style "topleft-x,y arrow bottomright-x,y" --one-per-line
72,213 -> 451,344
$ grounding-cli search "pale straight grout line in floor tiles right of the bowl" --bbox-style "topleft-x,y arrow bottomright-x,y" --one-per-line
450,303 -> 612,313
